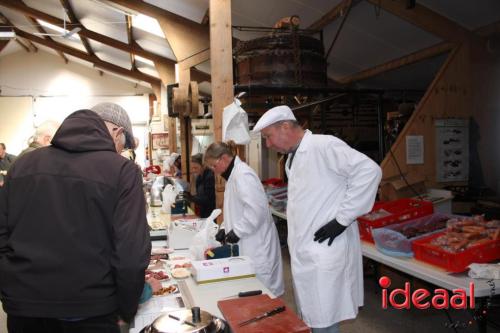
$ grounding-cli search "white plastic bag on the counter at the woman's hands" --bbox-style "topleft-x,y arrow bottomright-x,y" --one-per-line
189,209 -> 222,260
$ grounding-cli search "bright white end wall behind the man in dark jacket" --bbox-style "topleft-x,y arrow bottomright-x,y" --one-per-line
0,50 -> 152,165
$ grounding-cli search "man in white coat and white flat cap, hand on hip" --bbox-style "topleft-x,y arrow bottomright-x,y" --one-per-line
253,105 -> 381,332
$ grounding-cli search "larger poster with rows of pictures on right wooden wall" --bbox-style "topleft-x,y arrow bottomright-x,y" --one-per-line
434,118 -> 469,182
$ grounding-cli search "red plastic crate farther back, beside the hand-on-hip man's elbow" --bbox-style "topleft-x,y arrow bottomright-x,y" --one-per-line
358,198 -> 434,243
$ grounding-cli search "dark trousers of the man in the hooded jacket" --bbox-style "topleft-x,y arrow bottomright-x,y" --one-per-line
7,314 -> 120,333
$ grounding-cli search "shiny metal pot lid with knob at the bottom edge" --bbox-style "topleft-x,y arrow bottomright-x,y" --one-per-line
151,310 -> 214,333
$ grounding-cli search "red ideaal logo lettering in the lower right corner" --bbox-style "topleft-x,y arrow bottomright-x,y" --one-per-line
378,276 -> 475,310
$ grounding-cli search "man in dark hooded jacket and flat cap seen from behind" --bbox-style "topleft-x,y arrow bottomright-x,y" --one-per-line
0,103 -> 151,333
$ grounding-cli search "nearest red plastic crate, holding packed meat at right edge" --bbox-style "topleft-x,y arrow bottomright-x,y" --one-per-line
412,232 -> 500,273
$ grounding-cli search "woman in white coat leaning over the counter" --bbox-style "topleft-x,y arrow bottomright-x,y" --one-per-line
205,142 -> 285,296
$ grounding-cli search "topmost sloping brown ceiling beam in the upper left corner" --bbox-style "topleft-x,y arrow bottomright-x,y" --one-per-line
0,0 -> 175,65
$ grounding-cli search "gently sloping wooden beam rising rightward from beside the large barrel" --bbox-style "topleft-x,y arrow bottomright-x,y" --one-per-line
338,43 -> 455,84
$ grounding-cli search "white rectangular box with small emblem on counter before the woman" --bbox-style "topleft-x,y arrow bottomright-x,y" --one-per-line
191,256 -> 255,284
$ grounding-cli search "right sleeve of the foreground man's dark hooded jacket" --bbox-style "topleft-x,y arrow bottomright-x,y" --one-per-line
112,161 -> 151,322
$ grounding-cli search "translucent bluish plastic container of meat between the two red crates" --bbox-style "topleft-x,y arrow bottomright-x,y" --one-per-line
372,213 -> 461,257
